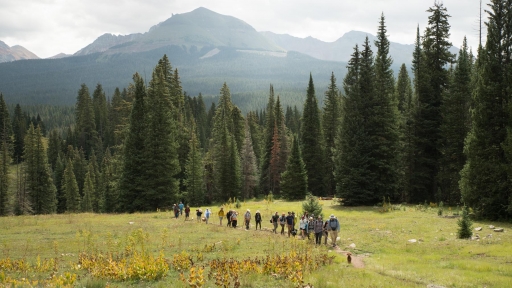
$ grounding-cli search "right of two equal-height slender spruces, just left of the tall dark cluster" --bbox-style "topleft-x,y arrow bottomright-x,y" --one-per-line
322,73 -> 341,195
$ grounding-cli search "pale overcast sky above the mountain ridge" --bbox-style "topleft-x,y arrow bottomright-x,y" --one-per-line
0,0 -> 489,58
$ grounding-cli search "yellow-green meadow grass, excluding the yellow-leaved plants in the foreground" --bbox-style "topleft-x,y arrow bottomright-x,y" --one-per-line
0,201 -> 512,287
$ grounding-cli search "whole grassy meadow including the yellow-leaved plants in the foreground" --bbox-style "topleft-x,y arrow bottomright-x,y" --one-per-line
0,200 -> 512,288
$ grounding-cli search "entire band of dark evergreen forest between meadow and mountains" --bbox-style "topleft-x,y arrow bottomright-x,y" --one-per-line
0,0 -> 512,220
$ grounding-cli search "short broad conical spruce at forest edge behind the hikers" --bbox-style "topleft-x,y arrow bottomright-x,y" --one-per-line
281,137 -> 308,200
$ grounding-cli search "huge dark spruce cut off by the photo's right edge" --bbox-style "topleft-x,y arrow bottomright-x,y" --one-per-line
460,0 -> 512,220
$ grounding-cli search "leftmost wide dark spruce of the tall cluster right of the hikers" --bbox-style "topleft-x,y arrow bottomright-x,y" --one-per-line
335,39 -> 376,205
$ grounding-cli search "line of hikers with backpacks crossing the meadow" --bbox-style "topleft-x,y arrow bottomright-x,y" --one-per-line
173,202 -> 340,247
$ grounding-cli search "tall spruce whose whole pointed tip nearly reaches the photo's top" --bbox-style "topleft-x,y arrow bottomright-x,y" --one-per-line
410,2 -> 453,203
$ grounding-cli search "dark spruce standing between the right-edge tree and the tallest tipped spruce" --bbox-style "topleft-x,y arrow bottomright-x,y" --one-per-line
437,37 -> 472,204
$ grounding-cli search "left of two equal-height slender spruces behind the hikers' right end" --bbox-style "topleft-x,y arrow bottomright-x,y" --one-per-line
300,74 -> 325,195
